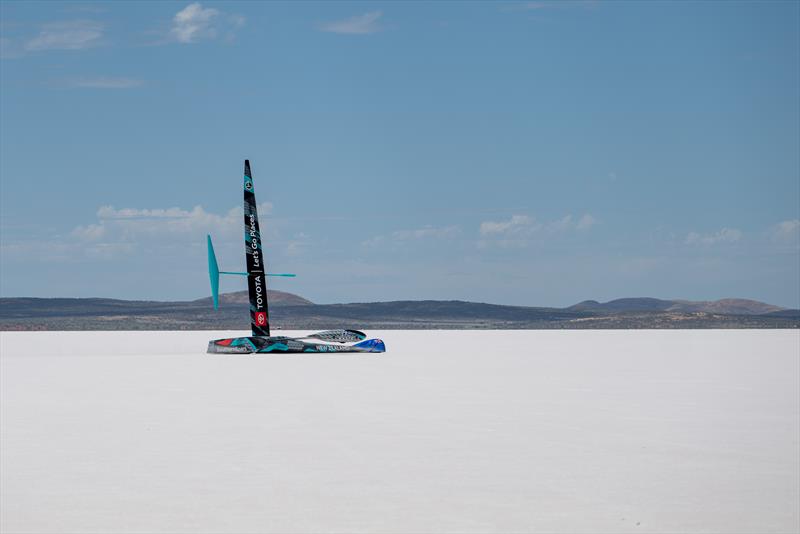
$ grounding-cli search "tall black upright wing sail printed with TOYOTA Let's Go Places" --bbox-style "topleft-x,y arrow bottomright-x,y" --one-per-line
244,160 -> 269,336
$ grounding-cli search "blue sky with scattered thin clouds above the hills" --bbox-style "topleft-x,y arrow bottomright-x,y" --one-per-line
0,2 -> 800,307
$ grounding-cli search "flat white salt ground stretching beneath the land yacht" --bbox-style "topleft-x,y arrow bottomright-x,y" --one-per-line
0,330 -> 800,533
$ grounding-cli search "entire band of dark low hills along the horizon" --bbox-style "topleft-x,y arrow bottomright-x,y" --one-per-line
0,290 -> 800,330
